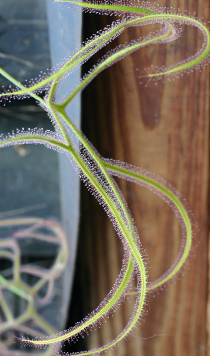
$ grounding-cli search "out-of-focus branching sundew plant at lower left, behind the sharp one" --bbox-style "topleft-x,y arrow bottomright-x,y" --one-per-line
0,217 -> 68,356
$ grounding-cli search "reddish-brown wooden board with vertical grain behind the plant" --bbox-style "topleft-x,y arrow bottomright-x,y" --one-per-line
78,0 -> 210,356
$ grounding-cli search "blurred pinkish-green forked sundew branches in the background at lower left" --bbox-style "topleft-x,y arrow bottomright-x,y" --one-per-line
0,218 -> 68,356
